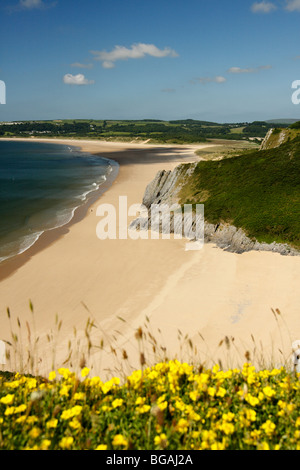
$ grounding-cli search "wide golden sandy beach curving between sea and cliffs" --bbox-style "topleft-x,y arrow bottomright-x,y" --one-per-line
0,139 -> 300,377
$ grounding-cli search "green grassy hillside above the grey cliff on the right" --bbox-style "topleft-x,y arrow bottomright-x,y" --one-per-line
180,130 -> 300,248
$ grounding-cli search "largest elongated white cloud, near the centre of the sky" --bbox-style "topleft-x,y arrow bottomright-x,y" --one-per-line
91,43 -> 178,68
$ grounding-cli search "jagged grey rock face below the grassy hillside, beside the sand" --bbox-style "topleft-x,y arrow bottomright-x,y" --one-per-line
130,163 -> 300,256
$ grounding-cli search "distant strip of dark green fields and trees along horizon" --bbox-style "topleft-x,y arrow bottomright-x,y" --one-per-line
0,119 -> 282,144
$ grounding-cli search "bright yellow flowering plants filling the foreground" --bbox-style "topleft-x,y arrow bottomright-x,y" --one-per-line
0,360 -> 300,450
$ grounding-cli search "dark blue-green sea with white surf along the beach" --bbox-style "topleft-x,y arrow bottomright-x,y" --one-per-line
0,140 -> 116,263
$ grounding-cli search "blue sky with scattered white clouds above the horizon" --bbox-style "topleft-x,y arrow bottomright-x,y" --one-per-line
0,0 -> 300,123
